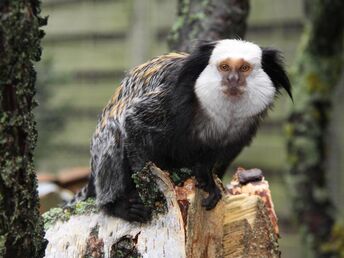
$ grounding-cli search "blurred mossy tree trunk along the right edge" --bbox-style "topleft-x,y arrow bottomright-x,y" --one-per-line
287,0 -> 344,257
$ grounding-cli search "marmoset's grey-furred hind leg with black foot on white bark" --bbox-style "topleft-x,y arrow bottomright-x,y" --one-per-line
95,133 -> 151,222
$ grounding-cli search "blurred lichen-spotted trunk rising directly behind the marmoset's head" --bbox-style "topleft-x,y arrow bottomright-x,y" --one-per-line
169,0 -> 249,52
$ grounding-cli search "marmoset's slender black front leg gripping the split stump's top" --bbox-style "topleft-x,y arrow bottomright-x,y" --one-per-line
194,164 -> 222,210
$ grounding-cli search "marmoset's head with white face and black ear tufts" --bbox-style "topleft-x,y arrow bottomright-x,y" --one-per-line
190,39 -> 292,117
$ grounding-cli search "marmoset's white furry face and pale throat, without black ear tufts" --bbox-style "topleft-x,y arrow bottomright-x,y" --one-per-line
195,40 -> 276,143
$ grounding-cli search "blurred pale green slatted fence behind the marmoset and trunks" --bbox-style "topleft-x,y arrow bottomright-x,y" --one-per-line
36,0 -> 344,258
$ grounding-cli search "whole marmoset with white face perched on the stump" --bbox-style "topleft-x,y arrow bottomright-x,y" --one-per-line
72,39 -> 292,222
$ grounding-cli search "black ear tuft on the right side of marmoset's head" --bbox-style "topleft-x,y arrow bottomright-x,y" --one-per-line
262,48 -> 293,100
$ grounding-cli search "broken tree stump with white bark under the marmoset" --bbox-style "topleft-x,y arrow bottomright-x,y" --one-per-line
44,164 -> 280,258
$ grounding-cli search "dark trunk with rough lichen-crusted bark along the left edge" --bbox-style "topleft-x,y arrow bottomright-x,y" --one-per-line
0,0 -> 46,258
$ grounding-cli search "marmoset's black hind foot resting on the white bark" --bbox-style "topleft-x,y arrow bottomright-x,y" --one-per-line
103,191 -> 152,223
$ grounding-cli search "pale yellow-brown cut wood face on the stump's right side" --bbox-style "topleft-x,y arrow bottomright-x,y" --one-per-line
223,194 -> 280,257
